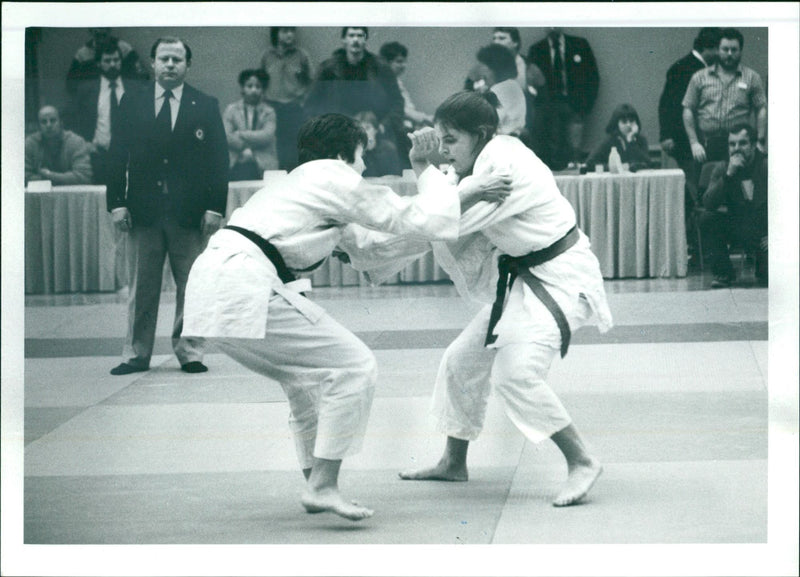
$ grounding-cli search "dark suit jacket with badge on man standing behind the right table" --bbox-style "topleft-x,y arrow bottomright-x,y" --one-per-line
528,34 -> 600,116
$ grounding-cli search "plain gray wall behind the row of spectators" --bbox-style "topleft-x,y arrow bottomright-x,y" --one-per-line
34,27 -> 768,147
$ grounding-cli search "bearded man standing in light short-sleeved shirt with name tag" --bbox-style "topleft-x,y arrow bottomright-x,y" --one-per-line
683,28 -> 767,163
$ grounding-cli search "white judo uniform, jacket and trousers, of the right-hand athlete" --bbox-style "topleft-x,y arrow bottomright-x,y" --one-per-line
341,136 -> 613,443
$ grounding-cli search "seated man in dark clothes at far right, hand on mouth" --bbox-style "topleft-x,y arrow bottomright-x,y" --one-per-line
700,124 -> 768,288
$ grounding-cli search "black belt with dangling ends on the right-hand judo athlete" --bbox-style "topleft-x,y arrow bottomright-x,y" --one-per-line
484,225 -> 580,358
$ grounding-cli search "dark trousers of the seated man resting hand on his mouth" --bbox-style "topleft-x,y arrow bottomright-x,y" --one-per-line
700,211 -> 769,280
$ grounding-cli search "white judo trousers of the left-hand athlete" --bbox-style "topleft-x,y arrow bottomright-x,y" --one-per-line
209,293 -> 377,469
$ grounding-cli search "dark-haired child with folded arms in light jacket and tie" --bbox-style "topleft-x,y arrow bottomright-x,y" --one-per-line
222,69 -> 278,180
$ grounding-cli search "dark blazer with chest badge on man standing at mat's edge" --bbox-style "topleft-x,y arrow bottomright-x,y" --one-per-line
106,83 -> 228,228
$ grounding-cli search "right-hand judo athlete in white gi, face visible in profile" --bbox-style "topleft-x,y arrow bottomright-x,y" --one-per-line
340,92 -> 612,506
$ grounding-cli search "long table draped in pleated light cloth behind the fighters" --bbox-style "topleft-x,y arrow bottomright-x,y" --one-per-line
25,170 -> 687,294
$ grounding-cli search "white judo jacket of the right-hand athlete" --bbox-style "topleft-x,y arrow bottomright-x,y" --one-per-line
341,135 -> 613,347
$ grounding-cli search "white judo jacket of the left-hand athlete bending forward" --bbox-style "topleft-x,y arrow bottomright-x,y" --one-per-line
183,160 -> 461,339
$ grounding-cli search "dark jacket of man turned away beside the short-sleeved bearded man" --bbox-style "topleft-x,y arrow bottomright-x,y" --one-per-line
658,52 -> 705,160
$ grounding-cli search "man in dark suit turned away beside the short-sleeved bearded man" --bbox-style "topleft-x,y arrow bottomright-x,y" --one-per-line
658,28 -> 720,172
